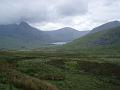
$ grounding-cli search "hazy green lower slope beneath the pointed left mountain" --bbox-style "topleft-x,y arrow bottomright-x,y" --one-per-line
0,36 -> 49,50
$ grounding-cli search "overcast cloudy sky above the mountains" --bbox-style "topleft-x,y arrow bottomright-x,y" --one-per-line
0,0 -> 120,31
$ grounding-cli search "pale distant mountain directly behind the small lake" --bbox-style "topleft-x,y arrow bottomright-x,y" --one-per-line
46,27 -> 89,42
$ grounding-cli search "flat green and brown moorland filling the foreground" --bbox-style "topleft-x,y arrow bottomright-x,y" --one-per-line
0,51 -> 120,90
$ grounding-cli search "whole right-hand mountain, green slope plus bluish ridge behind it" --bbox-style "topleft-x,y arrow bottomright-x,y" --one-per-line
62,21 -> 120,52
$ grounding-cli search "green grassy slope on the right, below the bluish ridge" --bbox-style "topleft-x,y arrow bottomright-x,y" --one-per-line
60,27 -> 120,54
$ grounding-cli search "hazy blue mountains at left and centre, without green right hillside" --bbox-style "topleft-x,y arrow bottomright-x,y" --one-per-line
0,22 -> 88,50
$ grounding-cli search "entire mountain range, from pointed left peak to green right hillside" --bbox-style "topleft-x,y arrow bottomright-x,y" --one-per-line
0,21 -> 120,50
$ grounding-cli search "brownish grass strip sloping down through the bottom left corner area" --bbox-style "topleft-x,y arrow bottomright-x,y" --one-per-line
0,62 -> 58,90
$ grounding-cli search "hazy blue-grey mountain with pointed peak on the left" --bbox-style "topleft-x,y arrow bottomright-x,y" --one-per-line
0,22 -> 52,49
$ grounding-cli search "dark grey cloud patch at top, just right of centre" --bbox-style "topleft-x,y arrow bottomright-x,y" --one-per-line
58,0 -> 88,16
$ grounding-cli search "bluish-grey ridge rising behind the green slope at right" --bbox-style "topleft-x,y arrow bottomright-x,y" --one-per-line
91,21 -> 120,33
